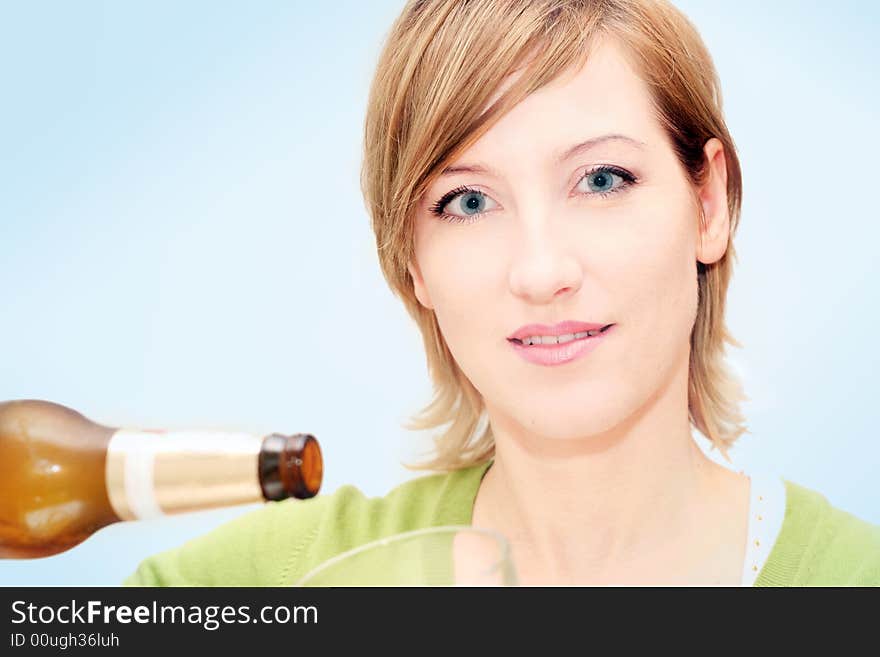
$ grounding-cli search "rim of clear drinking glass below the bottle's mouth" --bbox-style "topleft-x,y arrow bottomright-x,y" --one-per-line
294,525 -> 517,586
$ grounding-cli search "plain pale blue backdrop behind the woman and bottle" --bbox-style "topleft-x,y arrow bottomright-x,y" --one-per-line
0,0 -> 880,585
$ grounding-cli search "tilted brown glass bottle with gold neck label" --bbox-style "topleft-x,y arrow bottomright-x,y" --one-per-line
0,400 -> 323,559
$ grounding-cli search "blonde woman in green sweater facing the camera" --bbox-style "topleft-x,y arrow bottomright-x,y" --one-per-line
127,0 -> 880,585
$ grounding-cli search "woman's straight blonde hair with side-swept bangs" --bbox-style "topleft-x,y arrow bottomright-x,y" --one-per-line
361,0 -> 748,471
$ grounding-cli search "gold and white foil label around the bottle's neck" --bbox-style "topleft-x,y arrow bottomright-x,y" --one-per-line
106,429 -> 263,520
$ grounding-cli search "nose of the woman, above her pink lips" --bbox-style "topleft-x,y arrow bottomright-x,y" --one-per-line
509,221 -> 583,305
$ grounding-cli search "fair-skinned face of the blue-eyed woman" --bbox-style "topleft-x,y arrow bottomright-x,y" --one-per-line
410,41 -> 727,440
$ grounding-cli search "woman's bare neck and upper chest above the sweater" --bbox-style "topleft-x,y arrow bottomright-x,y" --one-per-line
474,352 -> 748,581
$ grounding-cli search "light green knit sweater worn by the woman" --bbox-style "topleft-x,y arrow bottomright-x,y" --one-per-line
124,461 -> 880,586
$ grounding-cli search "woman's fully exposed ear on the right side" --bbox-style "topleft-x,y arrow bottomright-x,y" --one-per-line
697,137 -> 730,265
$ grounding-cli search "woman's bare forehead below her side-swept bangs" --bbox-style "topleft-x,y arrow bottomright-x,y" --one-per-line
456,38 -> 662,164
